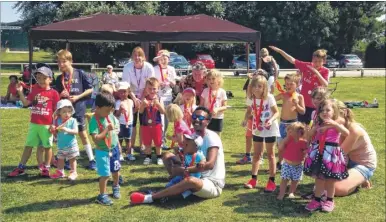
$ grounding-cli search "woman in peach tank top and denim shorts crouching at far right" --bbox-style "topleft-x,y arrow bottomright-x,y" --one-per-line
335,102 -> 377,196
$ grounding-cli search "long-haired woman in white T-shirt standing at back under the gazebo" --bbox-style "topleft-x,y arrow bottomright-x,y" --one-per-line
122,46 -> 155,147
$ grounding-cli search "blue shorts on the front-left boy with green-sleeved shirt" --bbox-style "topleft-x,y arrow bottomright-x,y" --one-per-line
95,146 -> 121,177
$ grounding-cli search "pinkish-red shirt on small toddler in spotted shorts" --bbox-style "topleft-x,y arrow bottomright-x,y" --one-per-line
283,137 -> 307,162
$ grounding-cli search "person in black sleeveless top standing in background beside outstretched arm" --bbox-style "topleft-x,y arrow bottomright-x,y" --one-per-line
259,48 -> 279,93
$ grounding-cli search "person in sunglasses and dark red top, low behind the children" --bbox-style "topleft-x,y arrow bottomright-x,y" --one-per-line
180,61 -> 208,105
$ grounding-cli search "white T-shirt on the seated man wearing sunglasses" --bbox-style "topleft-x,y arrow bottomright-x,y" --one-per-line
200,129 -> 225,188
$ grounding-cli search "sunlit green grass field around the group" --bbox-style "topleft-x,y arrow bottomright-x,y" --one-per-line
0,78 -> 385,221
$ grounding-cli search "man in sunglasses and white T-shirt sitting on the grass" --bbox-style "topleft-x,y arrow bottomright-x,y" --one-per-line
130,107 -> 225,204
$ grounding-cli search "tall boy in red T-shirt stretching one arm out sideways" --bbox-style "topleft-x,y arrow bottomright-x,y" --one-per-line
270,46 -> 329,125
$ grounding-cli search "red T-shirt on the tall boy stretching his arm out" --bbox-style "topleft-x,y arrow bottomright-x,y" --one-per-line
295,59 -> 329,108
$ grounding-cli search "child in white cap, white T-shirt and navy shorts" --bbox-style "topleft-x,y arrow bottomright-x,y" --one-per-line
114,82 -> 135,161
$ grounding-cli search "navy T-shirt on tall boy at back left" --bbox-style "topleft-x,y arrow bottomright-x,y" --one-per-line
56,69 -> 93,116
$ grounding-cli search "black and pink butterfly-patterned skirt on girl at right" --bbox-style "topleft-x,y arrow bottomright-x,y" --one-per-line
303,141 -> 348,180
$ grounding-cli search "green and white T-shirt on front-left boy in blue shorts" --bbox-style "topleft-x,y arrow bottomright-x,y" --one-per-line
88,114 -> 119,151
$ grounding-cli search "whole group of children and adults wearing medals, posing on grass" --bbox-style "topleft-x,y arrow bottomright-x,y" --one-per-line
3,46 -> 377,212
